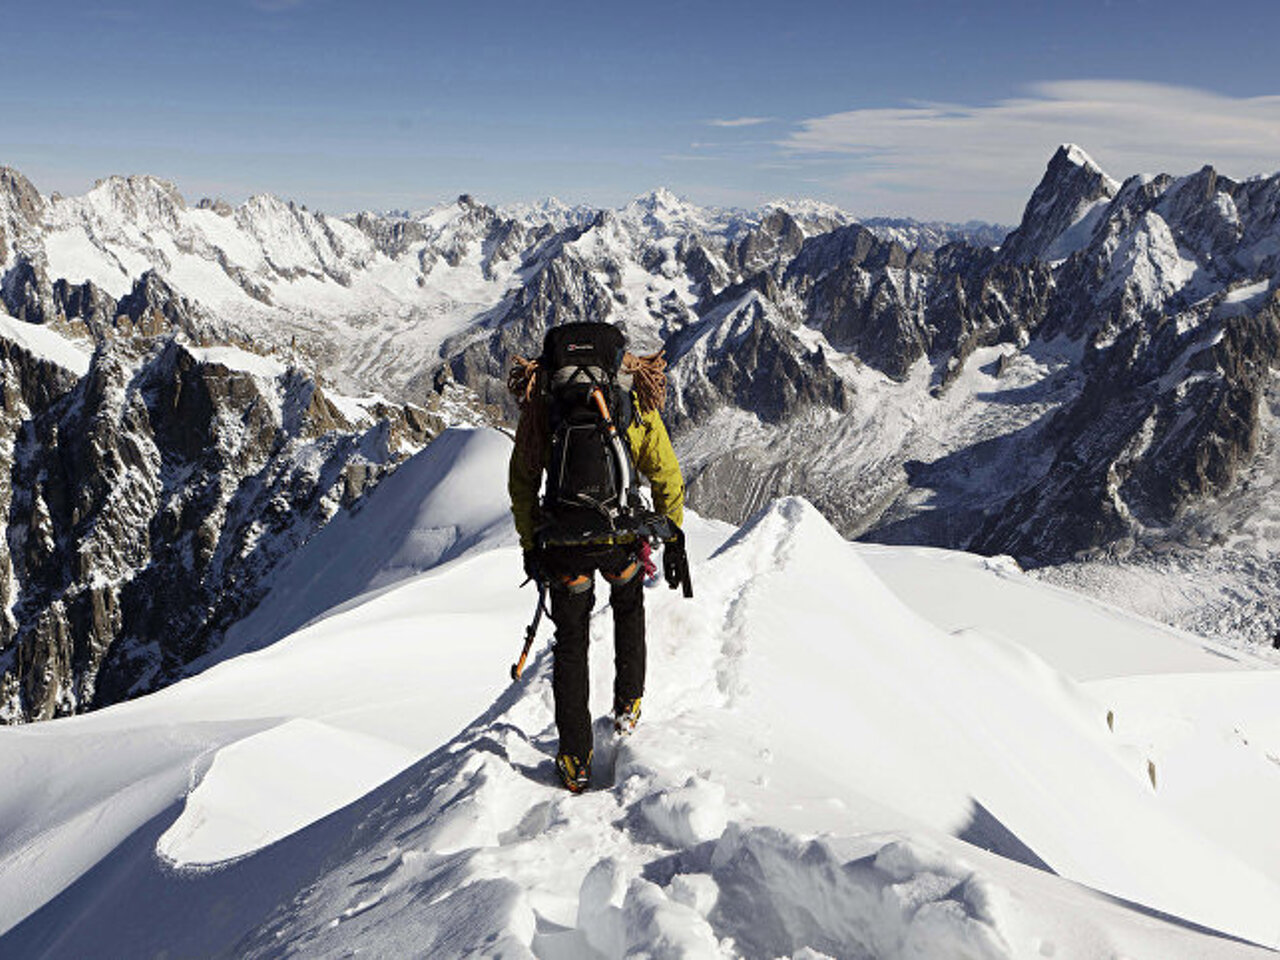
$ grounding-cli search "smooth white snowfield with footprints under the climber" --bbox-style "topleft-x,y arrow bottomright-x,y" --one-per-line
0,430 -> 1280,960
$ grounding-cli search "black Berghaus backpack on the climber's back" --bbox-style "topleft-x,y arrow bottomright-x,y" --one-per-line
539,323 -> 640,544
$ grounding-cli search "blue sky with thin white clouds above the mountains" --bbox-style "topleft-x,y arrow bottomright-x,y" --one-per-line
0,0 -> 1280,223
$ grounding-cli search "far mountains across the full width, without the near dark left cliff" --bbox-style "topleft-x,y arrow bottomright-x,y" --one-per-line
0,145 -> 1280,696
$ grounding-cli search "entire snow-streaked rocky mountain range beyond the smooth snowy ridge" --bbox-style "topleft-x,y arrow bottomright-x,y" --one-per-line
0,146 -> 1280,718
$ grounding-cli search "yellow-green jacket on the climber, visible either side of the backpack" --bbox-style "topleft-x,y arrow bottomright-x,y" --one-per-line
507,398 -> 685,550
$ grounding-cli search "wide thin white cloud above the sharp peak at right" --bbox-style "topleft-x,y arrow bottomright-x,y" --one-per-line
778,79 -> 1280,223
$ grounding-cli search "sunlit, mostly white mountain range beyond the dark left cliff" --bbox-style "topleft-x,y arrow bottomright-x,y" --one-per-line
0,168 -> 991,399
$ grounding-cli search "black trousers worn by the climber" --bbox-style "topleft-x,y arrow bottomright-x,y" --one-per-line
543,547 -> 645,759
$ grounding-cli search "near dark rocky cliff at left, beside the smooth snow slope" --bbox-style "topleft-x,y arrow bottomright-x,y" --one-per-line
0,335 -> 431,721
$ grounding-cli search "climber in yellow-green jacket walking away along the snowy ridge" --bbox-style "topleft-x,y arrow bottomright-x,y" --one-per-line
507,323 -> 692,792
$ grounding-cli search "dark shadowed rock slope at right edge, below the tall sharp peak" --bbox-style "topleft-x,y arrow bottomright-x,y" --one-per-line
969,291 -> 1280,566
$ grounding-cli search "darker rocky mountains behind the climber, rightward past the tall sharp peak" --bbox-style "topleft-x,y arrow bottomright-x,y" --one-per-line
422,145 -> 1280,639
